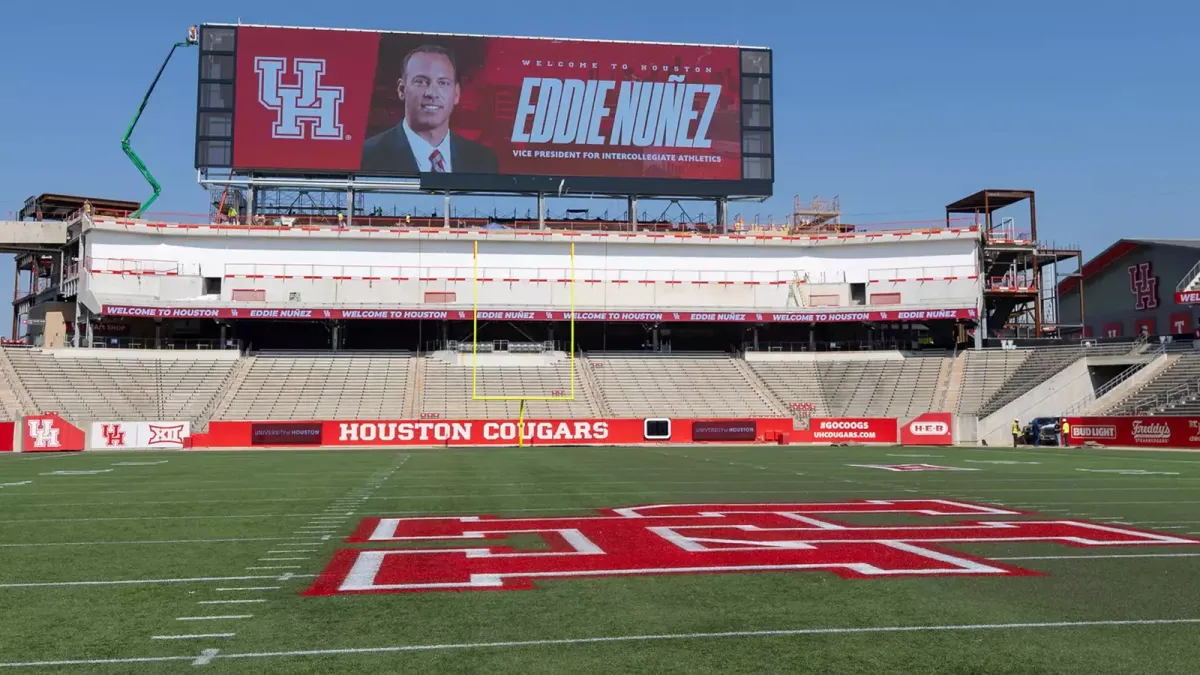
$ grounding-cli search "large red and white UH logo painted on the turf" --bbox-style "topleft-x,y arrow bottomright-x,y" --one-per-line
305,500 -> 1200,596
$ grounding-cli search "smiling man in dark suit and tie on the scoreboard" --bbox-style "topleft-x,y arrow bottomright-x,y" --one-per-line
360,44 -> 497,174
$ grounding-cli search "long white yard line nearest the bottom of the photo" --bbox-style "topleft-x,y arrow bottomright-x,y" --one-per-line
7,619 -> 1200,668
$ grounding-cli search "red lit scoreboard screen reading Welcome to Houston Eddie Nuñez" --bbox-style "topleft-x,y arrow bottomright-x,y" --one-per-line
232,26 -> 744,181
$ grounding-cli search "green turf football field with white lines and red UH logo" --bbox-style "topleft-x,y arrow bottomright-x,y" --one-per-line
0,447 -> 1200,675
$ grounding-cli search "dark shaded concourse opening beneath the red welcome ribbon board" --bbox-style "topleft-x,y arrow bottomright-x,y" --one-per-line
124,315 -> 968,351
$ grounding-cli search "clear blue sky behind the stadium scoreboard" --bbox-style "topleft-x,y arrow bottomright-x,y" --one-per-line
0,0 -> 1200,331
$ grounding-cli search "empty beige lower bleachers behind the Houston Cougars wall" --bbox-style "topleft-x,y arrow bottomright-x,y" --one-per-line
0,342 -> 1200,430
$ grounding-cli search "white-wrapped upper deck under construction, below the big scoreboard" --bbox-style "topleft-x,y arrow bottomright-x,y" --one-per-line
5,187 -> 1080,348
